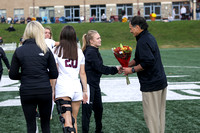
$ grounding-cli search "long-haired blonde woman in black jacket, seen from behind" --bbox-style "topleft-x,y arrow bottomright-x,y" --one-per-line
9,21 -> 58,133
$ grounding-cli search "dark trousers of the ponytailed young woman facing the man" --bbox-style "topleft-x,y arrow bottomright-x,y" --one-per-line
82,86 -> 103,133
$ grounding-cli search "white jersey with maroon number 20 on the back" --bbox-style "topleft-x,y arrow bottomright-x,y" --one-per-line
54,49 -> 85,98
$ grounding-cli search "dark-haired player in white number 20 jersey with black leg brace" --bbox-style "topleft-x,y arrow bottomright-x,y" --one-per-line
54,26 -> 88,133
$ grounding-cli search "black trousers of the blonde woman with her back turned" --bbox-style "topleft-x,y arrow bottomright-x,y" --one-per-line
21,93 -> 52,133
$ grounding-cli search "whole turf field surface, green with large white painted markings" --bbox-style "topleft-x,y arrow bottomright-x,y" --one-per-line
0,48 -> 200,133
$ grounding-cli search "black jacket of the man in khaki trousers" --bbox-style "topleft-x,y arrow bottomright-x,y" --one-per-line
134,30 -> 167,92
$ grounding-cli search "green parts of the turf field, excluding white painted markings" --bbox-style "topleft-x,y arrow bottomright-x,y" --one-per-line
0,48 -> 200,133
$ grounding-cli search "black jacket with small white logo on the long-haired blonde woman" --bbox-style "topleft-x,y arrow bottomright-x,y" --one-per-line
9,39 -> 58,95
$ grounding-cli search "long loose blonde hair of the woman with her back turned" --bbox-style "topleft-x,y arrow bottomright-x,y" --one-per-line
23,21 -> 48,53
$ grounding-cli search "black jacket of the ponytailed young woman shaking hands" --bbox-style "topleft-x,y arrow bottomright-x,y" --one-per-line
84,46 -> 118,87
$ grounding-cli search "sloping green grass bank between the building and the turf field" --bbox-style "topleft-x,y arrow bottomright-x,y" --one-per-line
0,21 -> 200,49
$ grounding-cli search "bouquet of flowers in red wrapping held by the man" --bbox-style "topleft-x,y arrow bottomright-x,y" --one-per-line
112,44 -> 132,85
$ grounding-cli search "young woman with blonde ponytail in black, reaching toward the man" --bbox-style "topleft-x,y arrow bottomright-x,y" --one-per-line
82,30 -> 121,133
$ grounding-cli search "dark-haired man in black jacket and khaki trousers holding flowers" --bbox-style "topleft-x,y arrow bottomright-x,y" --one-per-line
123,16 -> 167,133
